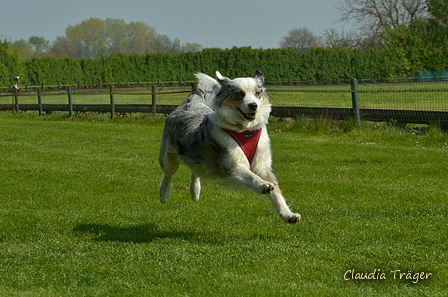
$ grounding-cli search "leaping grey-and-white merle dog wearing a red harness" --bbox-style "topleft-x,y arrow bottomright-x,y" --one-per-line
159,70 -> 300,224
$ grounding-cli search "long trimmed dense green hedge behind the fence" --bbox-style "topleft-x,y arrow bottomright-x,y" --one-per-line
0,47 -> 440,86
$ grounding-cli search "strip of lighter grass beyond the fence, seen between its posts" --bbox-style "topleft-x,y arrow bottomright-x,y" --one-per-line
0,82 -> 448,111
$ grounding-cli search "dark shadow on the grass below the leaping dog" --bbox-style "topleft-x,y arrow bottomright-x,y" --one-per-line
73,223 -> 198,243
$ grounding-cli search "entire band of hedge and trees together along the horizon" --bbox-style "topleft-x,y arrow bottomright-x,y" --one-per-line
0,0 -> 448,86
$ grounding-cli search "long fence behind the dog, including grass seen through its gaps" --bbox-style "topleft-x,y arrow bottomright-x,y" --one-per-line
0,79 -> 448,124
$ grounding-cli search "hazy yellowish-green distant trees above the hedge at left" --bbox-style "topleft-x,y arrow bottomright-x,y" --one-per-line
7,18 -> 202,59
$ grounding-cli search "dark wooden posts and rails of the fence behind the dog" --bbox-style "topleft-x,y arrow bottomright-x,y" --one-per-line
0,80 -> 448,125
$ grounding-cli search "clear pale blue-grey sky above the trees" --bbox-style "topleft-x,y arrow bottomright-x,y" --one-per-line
0,0 -> 343,48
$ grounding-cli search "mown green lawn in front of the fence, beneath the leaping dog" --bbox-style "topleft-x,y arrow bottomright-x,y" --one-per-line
0,113 -> 448,296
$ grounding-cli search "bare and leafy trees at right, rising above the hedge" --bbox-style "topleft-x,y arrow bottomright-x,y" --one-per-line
280,0 -> 448,60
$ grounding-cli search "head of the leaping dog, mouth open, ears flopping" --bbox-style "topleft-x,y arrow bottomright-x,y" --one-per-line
213,70 -> 271,131
